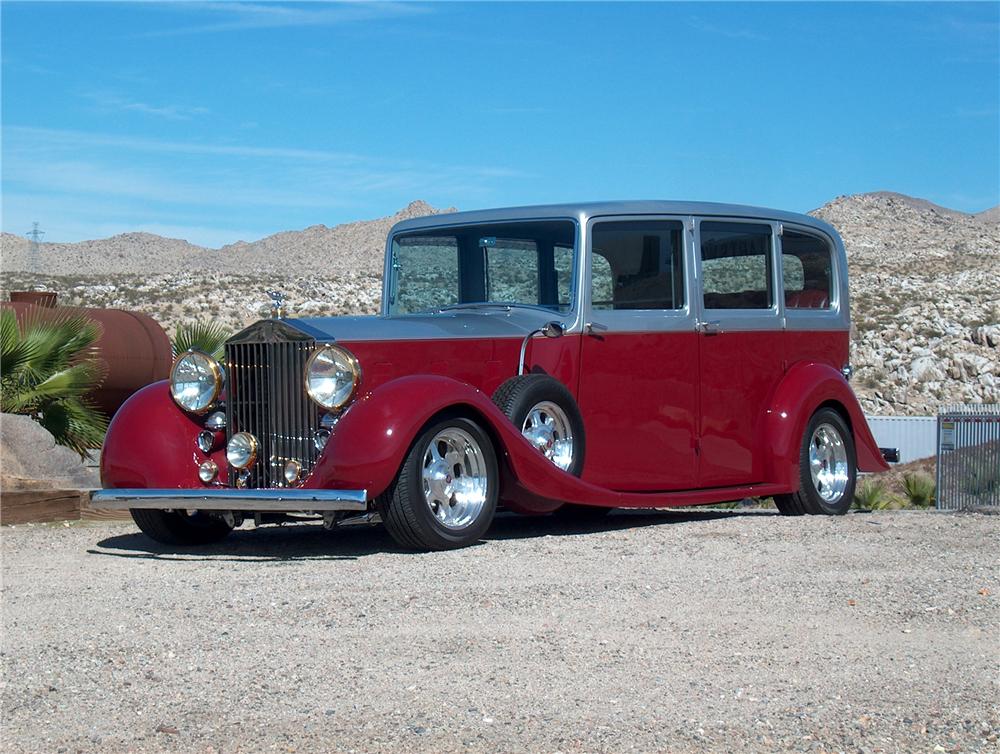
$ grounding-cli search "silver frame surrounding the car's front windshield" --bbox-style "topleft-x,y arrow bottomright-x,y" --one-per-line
381,216 -> 584,322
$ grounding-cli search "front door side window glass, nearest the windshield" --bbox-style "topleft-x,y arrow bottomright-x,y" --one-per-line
590,220 -> 684,309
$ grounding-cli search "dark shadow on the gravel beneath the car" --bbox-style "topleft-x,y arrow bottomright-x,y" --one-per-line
87,502 -> 777,562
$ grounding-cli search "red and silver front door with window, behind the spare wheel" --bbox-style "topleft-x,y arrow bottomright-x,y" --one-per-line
578,216 -> 699,491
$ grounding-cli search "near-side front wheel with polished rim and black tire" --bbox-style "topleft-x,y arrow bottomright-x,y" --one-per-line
377,417 -> 500,550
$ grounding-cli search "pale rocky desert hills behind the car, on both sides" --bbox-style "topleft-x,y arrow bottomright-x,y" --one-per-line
0,192 -> 1000,414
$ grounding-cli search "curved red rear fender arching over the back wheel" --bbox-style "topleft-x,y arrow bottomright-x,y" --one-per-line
758,362 -> 889,490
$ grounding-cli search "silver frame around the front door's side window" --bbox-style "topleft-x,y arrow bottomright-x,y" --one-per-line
581,214 -> 695,333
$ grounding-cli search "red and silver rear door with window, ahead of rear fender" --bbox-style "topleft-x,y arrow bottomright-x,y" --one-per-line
695,218 -> 784,487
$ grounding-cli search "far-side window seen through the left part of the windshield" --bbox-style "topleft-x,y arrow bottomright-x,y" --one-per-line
392,236 -> 458,314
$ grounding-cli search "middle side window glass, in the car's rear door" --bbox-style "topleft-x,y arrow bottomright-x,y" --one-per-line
701,221 -> 774,309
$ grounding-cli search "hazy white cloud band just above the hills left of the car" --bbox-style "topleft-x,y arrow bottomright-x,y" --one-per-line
2,126 -> 529,241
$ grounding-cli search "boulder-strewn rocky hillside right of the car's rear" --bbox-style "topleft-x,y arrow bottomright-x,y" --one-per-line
811,192 -> 1000,414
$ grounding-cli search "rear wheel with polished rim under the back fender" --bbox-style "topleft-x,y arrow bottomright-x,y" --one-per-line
774,408 -> 858,516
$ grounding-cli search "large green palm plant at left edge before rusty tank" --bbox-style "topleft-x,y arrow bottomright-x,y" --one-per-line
0,309 -> 108,456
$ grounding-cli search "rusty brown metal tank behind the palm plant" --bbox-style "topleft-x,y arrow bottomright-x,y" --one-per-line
0,291 -> 173,417
